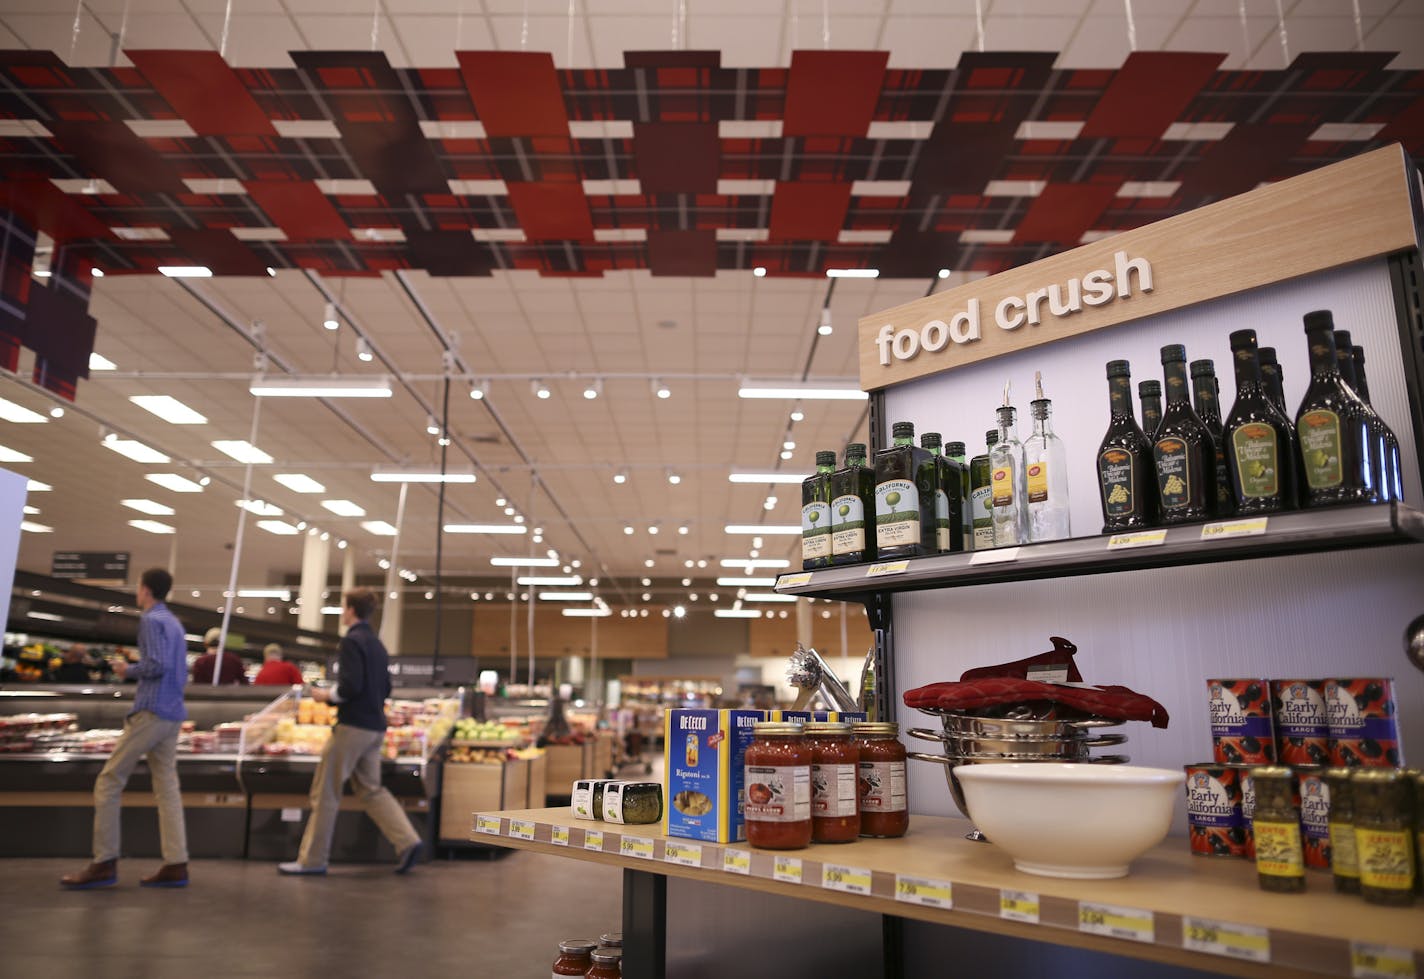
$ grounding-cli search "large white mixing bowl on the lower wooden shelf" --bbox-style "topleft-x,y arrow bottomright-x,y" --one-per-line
954,761 -> 1186,878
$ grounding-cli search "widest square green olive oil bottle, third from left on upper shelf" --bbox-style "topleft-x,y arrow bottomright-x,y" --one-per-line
876,421 -> 940,561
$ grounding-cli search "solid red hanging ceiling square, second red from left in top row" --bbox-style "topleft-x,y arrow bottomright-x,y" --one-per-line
456,51 -> 568,137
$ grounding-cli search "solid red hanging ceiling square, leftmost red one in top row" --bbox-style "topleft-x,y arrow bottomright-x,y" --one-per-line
124,51 -> 276,137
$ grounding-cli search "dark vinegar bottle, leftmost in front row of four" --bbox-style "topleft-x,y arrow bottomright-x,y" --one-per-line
1098,360 -> 1158,534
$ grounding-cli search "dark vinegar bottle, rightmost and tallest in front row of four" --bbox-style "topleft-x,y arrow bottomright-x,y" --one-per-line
1296,309 -> 1378,507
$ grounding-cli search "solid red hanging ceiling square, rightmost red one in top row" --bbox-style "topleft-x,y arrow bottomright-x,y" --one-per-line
1079,51 -> 1226,139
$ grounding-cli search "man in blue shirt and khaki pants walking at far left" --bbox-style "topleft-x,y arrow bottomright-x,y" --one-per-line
60,568 -> 188,889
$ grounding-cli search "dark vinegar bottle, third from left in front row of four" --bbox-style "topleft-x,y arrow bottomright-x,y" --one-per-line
1225,330 -> 1296,514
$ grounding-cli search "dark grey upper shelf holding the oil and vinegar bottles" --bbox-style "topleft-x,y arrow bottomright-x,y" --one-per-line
776,504 -> 1424,599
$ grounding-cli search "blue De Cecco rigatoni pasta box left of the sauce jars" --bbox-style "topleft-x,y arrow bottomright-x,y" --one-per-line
662,709 -> 768,842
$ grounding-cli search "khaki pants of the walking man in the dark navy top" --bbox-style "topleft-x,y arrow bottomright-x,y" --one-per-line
296,724 -> 420,867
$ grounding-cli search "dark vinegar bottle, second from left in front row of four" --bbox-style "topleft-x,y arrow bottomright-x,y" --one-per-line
1152,343 -> 1216,524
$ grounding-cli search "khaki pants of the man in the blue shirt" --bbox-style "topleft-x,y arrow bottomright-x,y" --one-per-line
94,710 -> 188,864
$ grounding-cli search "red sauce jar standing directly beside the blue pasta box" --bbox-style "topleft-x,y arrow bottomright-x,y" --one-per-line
745,721 -> 812,850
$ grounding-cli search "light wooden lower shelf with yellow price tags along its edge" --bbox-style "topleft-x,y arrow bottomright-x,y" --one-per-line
470,807 -> 1424,976
